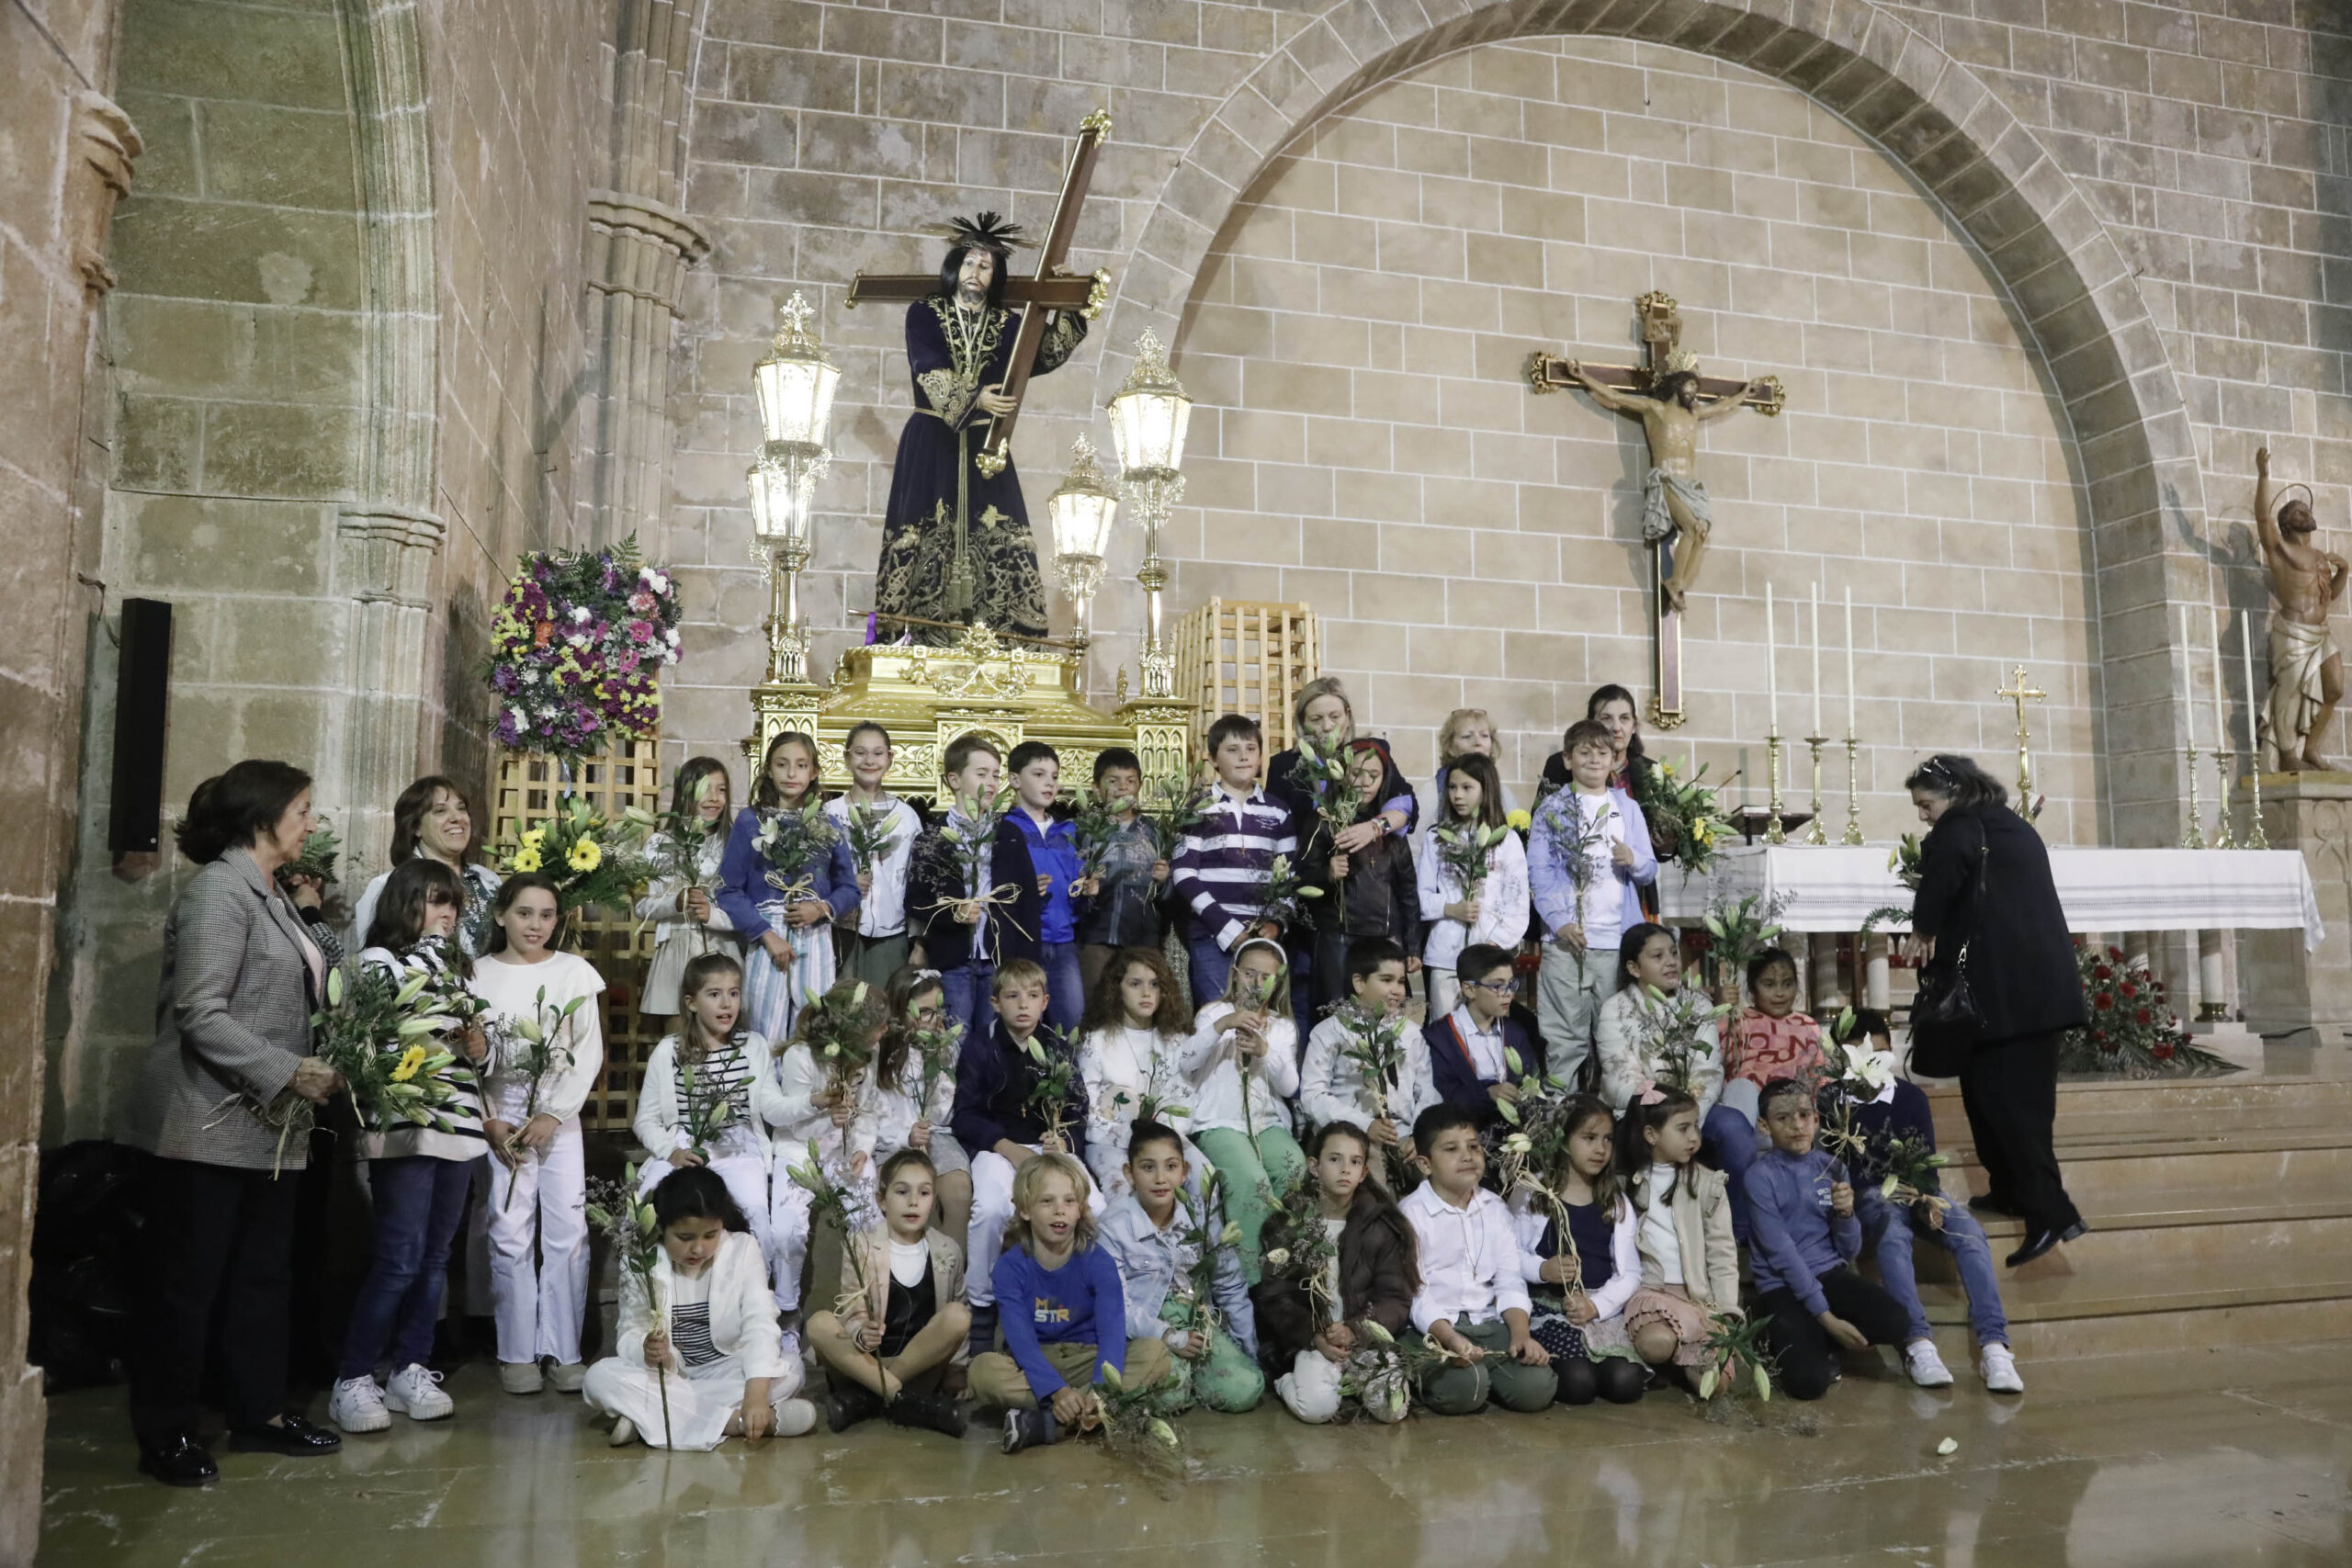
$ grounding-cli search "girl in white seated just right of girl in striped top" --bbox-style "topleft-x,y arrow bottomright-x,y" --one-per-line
752,980 -> 889,1314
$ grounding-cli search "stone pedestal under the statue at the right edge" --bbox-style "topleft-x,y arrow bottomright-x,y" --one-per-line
2239,773 -> 2352,1046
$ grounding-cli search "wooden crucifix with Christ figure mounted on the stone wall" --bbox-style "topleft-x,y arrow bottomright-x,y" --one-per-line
1526,289 -> 1788,728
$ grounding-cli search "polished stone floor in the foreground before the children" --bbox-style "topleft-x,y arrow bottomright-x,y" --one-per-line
40,1345 -> 2352,1568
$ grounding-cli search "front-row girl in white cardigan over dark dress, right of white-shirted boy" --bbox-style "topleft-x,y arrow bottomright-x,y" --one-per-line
1512,1096 -> 1649,1405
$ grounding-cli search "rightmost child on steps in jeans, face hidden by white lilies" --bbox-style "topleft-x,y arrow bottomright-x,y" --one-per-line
1847,1029 -> 2025,1394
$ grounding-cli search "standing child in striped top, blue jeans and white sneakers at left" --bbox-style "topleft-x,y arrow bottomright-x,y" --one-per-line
327,856 -> 489,1432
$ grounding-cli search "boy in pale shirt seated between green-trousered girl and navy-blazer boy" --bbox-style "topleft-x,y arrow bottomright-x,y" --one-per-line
1298,936 -> 1437,1192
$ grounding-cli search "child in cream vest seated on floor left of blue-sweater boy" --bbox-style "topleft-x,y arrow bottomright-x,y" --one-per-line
809,1149 -> 971,1437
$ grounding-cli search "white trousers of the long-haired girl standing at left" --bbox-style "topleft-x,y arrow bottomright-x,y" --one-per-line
489,1117 -> 588,1366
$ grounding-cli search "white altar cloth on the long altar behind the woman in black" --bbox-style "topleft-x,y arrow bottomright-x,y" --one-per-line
1658,844 -> 2324,950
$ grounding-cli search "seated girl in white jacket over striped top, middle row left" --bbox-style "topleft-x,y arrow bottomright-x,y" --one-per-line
633,952 -> 774,1256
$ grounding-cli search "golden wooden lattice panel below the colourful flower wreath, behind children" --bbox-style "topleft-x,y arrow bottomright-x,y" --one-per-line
489,740 -> 668,1128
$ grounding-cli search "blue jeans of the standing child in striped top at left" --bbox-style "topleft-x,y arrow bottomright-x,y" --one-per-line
336,1155 -> 473,1378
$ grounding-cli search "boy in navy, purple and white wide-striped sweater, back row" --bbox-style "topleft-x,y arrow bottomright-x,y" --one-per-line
1169,712 -> 1298,1006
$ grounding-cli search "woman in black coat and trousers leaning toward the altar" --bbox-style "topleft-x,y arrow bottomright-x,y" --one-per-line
1903,755 -> 2086,1267
